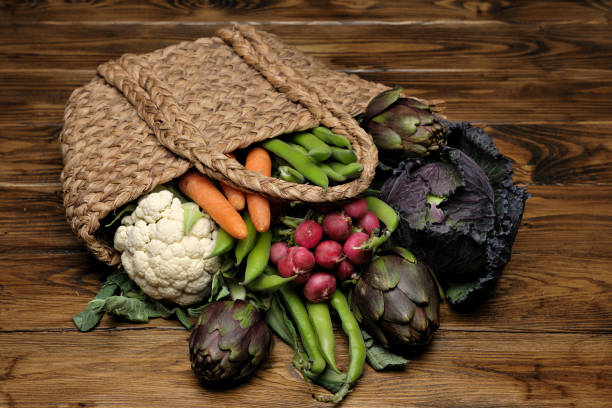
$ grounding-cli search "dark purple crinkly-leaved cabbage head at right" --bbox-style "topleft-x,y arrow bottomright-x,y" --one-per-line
381,122 -> 529,305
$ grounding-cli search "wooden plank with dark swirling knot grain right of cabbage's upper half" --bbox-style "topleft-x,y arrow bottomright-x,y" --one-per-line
0,120 -> 612,187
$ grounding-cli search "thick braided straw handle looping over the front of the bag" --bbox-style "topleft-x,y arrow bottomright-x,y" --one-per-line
98,26 -> 378,203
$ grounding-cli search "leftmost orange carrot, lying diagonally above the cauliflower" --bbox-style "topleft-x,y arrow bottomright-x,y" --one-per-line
178,171 -> 249,239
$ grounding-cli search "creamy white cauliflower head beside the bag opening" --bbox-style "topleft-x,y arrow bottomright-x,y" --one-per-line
114,189 -> 221,306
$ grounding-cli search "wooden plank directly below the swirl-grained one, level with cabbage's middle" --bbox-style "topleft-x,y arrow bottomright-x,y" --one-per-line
0,185 -> 612,257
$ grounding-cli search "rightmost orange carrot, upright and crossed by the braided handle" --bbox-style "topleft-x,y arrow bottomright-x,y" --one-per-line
244,147 -> 272,232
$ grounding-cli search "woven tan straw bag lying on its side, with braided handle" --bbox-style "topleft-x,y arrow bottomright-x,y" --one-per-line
60,26 -> 387,265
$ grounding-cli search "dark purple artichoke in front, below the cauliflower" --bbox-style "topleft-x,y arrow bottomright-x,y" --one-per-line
189,300 -> 271,385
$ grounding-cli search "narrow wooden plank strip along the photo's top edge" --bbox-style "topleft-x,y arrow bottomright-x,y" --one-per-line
0,0 -> 610,24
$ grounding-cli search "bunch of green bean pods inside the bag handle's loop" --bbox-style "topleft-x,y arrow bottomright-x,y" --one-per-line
262,126 -> 363,189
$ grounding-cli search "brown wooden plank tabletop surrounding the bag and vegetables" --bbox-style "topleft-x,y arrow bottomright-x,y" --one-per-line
0,0 -> 612,407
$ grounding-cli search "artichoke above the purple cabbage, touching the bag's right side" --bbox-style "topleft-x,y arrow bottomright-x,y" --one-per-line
362,88 -> 446,160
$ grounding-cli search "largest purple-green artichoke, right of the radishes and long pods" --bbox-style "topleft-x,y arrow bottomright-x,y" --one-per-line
351,250 -> 440,351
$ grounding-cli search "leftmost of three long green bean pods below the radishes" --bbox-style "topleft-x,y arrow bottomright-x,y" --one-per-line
279,286 -> 325,375
